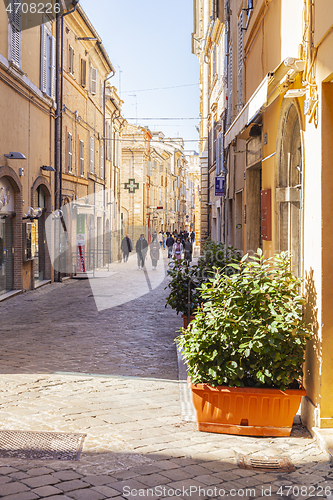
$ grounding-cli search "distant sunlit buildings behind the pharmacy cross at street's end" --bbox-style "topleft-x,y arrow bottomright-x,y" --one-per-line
120,123 -> 188,241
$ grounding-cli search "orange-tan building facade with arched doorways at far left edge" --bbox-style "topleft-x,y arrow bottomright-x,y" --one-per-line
0,2 -> 56,298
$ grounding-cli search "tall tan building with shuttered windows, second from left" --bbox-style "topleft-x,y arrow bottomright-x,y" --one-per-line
59,5 -> 123,274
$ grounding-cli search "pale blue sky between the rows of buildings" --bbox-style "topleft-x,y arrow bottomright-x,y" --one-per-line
80,0 -> 199,150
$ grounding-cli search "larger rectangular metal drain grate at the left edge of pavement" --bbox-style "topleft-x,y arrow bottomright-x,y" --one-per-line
0,431 -> 86,460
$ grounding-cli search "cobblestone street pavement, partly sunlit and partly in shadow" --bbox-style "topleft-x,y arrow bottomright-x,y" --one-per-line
0,256 -> 333,500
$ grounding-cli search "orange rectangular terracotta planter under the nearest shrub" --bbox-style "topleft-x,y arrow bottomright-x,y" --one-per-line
188,380 -> 306,436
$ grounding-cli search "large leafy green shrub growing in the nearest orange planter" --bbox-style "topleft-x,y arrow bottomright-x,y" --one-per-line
176,250 -> 310,389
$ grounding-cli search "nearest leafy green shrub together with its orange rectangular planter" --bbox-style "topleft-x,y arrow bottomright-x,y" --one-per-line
176,249 -> 310,436
